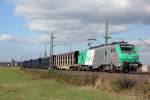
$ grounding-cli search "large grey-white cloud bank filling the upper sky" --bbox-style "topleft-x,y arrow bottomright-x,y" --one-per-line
9,0 -> 150,43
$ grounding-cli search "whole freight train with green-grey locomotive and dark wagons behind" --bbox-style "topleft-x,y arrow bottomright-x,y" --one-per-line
22,42 -> 142,72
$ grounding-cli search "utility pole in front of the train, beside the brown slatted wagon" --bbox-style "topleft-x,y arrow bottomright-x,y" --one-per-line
49,33 -> 55,69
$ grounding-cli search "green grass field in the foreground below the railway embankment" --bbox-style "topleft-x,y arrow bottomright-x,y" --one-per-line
0,68 -> 129,100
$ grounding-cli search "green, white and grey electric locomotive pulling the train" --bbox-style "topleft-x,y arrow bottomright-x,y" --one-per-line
78,42 -> 142,72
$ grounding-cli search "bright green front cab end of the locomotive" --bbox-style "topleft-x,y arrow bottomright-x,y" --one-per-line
116,42 -> 142,71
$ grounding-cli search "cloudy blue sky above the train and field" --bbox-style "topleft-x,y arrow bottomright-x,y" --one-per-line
0,0 -> 150,63
